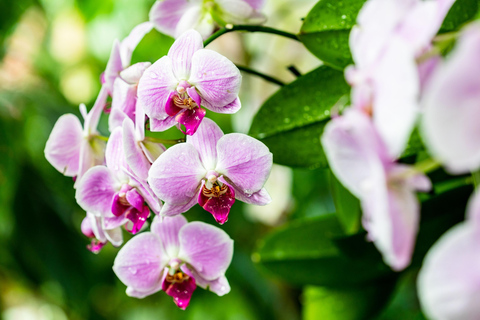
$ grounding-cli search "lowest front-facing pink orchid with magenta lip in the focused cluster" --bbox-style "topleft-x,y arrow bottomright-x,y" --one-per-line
113,215 -> 233,309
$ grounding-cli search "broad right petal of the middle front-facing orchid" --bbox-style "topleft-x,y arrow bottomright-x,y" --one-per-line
215,133 -> 273,194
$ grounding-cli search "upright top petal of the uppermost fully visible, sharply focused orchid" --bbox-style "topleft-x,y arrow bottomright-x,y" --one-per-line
168,30 -> 203,80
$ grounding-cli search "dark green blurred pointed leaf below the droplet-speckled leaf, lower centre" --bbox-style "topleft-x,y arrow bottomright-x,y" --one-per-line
253,214 -> 392,286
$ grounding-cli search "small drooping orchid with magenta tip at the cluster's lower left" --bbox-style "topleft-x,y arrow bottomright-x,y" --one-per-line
81,212 -> 123,253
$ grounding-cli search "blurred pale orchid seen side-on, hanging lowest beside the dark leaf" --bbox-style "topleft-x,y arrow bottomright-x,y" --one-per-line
322,109 -> 430,270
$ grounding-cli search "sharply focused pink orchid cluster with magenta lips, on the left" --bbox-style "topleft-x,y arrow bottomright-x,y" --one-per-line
45,0 -> 272,309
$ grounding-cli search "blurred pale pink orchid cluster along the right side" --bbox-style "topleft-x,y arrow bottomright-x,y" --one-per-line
322,0 -> 480,319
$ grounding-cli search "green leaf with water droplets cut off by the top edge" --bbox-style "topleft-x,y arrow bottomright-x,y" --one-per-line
299,0 -> 366,70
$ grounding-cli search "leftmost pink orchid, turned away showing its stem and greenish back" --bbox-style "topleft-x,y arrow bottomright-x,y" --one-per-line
45,88 -> 107,186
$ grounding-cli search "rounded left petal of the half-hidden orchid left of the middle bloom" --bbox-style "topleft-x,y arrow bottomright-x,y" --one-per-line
75,166 -> 120,215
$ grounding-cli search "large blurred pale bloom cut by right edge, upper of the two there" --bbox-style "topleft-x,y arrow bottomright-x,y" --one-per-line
422,23 -> 480,173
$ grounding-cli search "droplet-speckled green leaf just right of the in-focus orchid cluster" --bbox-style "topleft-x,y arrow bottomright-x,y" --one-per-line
250,66 -> 350,167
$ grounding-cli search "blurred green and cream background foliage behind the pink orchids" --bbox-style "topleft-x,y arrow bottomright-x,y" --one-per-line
0,0 -> 471,320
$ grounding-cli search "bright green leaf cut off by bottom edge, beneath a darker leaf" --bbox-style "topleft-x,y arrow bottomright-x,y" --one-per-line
303,276 -> 397,320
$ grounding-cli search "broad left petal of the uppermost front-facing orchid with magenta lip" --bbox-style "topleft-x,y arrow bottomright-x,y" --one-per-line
137,56 -> 179,120
